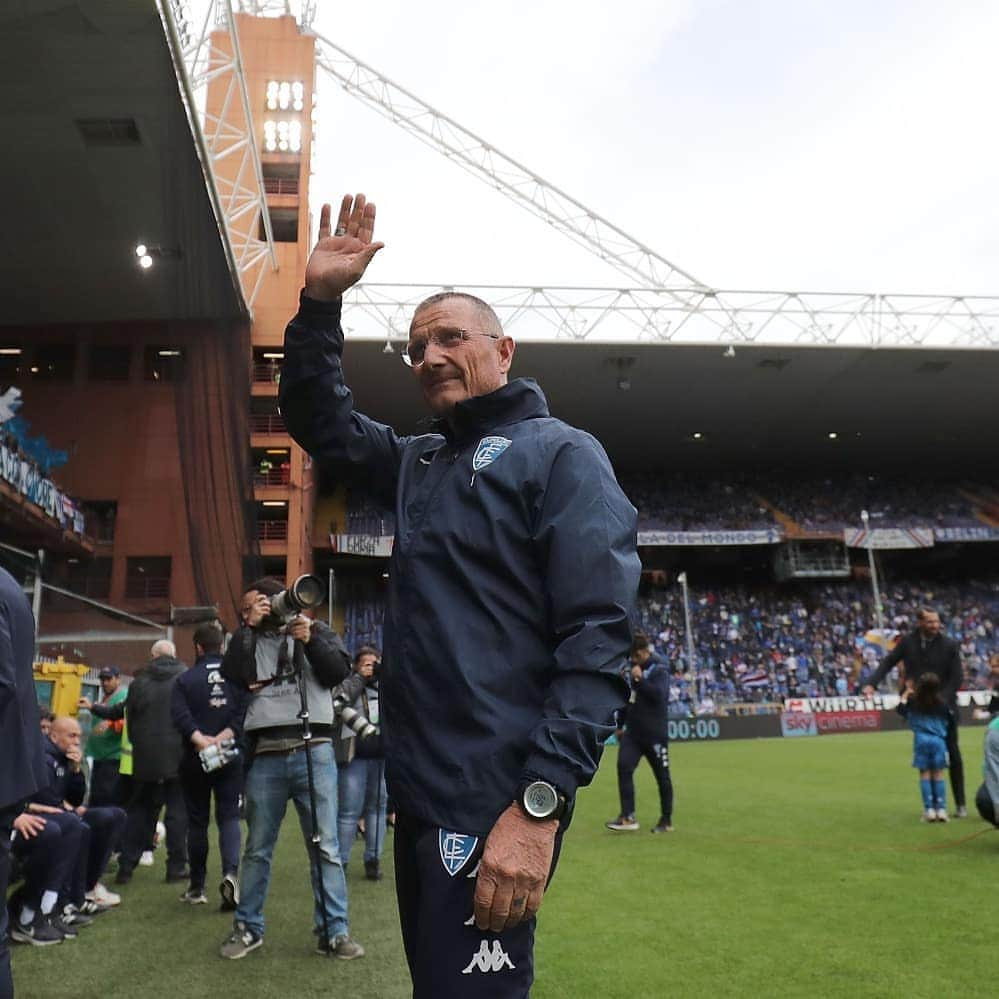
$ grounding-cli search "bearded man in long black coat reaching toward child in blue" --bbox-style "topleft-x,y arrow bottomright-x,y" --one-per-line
864,607 -> 968,819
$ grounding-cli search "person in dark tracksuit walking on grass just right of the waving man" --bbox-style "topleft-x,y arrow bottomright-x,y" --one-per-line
606,634 -> 673,833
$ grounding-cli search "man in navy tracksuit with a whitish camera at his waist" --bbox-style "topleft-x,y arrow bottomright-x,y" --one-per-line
170,623 -> 248,912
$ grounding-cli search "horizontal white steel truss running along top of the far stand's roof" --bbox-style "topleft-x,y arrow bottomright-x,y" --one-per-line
344,283 -> 999,349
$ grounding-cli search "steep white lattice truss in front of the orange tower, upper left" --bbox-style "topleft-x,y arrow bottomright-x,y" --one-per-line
157,0 -> 278,310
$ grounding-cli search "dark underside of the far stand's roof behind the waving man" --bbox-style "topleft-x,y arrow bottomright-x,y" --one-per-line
334,340 -> 999,478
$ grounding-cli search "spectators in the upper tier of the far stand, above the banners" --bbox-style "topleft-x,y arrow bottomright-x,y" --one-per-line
346,471 -> 999,535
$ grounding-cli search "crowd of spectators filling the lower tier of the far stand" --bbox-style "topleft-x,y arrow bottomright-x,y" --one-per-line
635,582 -> 999,714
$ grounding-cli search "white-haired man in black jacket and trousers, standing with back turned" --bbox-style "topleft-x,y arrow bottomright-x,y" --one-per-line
96,639 -> 188,885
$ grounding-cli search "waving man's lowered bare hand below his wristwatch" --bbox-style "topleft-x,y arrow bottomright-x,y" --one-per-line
475,803 -> 558,933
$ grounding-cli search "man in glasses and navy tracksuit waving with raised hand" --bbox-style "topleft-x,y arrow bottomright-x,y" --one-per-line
280,195 -> 641,999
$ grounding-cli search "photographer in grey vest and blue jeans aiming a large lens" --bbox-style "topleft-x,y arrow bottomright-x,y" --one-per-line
220,578 -> 364,960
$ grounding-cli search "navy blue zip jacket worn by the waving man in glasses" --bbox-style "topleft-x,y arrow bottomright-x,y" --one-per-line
281,295 -> 641,835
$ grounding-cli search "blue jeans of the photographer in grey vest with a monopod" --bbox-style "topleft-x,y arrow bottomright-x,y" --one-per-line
236,742 -> 348,939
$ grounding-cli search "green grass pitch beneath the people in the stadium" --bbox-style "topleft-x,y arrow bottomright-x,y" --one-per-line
14,728 -> 999,999
